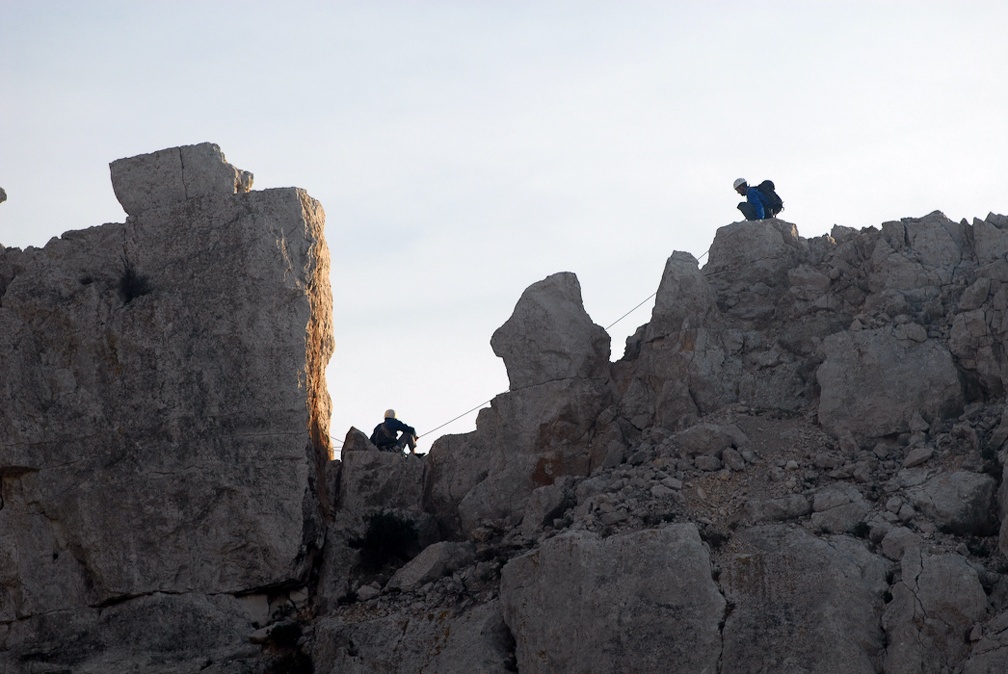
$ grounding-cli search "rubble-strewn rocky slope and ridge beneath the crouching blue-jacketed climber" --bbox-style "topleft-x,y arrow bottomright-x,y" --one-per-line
314,214 -> 1008,673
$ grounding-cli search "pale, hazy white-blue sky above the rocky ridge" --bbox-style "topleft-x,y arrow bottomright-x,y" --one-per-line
0,0 -> 1008,452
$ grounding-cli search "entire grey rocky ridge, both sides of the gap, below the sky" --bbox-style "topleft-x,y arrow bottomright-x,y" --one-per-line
0,144 -> 1008,674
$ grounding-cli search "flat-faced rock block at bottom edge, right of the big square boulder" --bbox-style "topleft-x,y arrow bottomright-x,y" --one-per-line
712,525 -> 888,674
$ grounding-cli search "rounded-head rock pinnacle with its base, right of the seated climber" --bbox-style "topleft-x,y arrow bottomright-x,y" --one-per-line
425,273 -> 611,535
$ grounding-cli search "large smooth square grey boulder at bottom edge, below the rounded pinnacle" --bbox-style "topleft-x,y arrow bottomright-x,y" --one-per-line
501,524 -> 725,674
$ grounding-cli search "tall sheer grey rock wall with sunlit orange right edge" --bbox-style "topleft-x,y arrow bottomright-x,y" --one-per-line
0,144 -> 333,671
